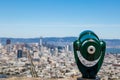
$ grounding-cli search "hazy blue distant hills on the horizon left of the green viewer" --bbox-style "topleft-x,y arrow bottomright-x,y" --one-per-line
0,37 -> 77,44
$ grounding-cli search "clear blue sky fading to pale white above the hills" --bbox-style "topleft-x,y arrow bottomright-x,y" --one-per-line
0,0 -> 120,39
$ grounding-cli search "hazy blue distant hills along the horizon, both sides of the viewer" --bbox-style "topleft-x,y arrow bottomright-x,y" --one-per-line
0,37 -> 120,47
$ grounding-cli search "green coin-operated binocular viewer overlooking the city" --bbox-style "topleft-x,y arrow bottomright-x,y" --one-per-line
73,30 -> 106,80
